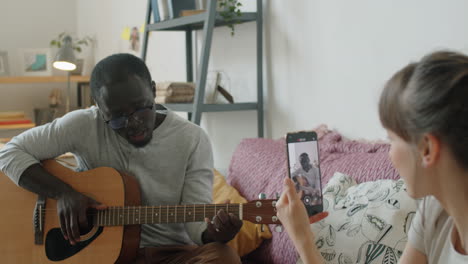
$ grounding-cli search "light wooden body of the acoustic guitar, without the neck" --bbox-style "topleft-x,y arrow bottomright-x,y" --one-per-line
0,160 -> 140,264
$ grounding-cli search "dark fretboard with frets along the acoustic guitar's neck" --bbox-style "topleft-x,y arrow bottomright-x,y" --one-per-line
96,204 -> 242,226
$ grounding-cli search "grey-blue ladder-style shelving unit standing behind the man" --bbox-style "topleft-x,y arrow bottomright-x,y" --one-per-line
142,0 -> 264,137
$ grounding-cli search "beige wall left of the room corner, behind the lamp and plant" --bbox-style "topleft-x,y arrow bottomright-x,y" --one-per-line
0,0 -> 77,137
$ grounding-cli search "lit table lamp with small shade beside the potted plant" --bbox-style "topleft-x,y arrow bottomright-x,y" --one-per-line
53,36 -> 76,113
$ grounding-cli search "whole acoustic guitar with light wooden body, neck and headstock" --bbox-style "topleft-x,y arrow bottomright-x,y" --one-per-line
0,160 -> 279,264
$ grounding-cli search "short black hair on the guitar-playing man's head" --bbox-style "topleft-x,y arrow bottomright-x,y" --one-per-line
90,53 -> 152,100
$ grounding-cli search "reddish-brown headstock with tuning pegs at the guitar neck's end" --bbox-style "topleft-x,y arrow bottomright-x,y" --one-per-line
242,199 -> 281,224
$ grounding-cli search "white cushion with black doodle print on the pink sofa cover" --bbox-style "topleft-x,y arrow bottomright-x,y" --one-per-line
298,173 -> 416,264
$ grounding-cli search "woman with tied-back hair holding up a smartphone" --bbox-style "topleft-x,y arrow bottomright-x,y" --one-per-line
277,51 -> 468,264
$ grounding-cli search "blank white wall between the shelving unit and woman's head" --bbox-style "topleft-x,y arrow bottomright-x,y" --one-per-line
265,0 -> 468,142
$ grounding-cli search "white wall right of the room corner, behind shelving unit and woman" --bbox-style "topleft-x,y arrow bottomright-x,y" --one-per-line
73,0 -> 468,171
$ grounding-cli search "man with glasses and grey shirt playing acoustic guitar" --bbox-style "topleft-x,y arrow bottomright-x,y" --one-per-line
0,54 -> 242,263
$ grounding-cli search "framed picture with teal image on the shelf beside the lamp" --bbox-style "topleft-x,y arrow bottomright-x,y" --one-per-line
19,49 -> 52,76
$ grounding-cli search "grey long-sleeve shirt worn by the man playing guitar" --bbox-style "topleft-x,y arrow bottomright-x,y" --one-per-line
0,107 -> 213,247
